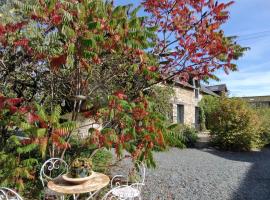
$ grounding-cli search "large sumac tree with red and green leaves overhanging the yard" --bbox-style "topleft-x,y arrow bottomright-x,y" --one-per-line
0,0 -> 248,170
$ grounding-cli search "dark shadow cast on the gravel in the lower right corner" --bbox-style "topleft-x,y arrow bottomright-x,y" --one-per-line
206,148 -> 270,200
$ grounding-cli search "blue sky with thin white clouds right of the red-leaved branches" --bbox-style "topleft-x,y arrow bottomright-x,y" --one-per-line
115,0 -> 270,96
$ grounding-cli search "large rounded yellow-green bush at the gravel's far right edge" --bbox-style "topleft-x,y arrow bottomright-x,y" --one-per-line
207,97 -> 263,150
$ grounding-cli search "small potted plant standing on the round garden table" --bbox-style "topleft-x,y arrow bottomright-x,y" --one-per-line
69,158 -> 93,178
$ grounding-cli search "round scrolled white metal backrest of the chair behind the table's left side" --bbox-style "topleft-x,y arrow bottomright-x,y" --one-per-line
39,158 -> 68,187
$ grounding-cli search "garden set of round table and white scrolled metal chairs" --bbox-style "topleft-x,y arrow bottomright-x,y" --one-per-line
0,158 -> 145,200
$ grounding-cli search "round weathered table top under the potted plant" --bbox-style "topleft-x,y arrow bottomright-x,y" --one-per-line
48,172 -> 110,194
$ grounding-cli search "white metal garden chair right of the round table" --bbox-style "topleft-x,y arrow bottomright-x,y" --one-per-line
109,162 -> 146,200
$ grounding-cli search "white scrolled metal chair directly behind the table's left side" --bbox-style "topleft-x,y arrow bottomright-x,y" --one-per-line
39,158 -> 68,199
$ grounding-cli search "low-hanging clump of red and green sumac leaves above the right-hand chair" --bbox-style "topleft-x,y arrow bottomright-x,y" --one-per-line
87,92 -> 166,166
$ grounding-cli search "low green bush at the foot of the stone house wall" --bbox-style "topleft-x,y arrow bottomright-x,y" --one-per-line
164,124 -> 198,149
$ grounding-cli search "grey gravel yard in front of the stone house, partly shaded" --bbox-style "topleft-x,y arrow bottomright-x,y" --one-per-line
143,149 -> 270,200
